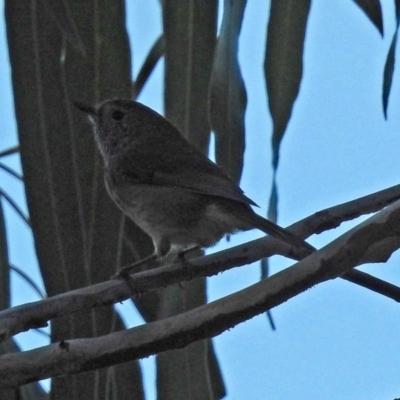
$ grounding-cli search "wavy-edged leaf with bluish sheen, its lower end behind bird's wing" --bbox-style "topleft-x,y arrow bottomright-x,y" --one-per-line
210,0 -> 247,183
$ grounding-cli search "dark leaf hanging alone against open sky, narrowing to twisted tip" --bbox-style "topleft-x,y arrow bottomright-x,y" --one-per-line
264,0 -> 311,169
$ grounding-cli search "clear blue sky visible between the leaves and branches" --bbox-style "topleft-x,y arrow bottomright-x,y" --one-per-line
0,0 -> 400,400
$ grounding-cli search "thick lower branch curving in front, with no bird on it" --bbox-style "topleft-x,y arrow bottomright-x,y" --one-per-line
0,198 -> 400,387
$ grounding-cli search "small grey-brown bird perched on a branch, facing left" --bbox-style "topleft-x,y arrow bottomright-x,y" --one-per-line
75,100 -> 315,276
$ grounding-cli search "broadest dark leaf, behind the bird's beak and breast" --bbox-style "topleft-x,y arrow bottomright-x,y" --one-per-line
5,0 -> 145,399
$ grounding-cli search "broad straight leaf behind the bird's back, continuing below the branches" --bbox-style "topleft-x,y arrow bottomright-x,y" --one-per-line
161,0 -> 225,400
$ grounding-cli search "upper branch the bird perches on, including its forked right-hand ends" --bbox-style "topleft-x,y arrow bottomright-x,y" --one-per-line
0,185 -> 400,341
